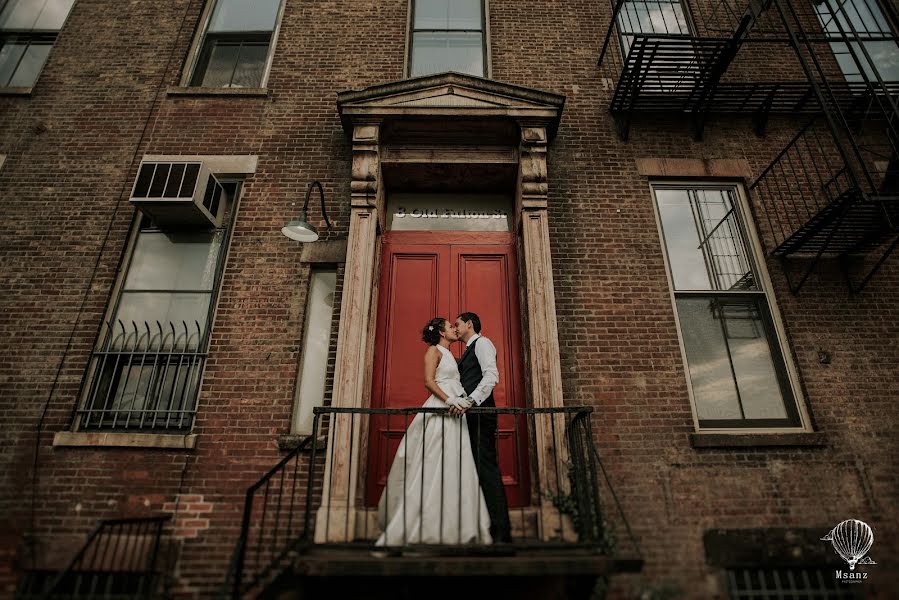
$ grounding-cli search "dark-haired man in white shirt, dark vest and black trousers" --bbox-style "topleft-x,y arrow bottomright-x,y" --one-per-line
450,312 -> 512,542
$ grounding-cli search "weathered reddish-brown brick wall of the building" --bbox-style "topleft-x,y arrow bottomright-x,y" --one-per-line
0,0 -> 899,597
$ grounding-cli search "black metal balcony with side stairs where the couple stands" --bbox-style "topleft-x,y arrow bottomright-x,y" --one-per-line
223,407 -> 642,598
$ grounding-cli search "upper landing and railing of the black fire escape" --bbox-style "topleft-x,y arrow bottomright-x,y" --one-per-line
599,0 -> 899,139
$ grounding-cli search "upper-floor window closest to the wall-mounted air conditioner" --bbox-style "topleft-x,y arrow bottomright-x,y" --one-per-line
190,0 -> 281,88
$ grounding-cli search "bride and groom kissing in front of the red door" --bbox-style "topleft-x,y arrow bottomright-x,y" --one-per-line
375,312 -> 511,547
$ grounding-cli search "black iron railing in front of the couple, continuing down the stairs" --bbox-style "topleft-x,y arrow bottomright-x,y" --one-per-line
225,407 -> 639,598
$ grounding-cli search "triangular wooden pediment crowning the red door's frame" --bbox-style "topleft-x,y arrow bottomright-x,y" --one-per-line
337,73 -> 565,134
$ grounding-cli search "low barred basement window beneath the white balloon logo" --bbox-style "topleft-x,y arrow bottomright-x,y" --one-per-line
727,567 -> 861,600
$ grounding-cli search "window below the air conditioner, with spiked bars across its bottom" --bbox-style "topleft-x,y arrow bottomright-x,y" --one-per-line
78,176 -> 239,433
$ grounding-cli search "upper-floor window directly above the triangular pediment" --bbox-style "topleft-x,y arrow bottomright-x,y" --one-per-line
409,0 -> 487,77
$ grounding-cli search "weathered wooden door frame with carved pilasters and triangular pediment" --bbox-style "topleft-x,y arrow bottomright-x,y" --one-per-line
315,73 -> 566,543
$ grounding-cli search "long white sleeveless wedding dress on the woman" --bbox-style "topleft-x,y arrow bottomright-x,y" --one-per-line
375,344 -> 492,546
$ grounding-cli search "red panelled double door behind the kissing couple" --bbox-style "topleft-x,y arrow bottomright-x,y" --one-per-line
366,231 -> 528,506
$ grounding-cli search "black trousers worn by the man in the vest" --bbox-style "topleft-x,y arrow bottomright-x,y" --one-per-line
466,413 -> 512,542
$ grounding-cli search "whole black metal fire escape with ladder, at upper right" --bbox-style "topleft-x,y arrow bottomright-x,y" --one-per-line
599,0 -> 899,293
